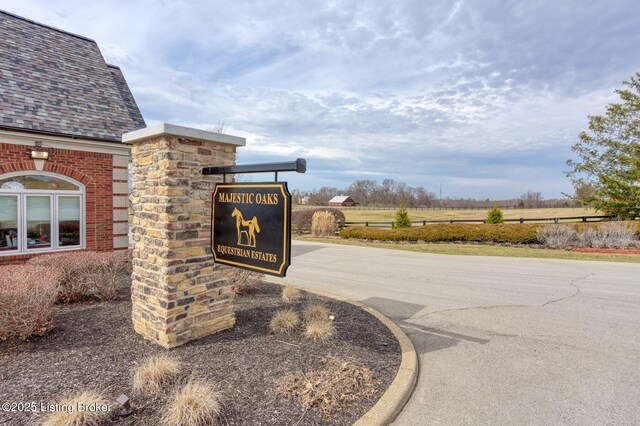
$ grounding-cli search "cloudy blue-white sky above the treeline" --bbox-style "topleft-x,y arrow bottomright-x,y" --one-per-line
5,0 -> 640,198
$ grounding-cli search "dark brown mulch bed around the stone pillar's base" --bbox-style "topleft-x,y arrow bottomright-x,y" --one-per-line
0,283 -> 401,425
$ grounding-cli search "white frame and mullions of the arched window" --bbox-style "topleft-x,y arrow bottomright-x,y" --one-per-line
0,170 -> 87,257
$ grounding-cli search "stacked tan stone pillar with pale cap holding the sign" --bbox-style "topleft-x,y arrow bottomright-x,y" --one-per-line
122,124 -> 245,348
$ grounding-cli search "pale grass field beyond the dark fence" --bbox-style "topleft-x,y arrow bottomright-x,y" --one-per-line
341,208 -> 602,222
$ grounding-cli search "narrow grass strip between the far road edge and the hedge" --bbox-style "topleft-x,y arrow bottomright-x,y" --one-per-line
296,236 -> 640,263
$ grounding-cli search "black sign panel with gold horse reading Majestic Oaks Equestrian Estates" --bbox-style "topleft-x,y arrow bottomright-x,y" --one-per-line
211,182 -> 291,277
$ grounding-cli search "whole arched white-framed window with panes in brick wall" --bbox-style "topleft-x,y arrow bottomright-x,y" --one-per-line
0,172 -> 85,256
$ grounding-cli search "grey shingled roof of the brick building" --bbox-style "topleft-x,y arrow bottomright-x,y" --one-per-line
0,11 -> 146,141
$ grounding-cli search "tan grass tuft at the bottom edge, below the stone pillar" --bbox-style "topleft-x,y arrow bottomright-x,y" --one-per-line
162,380 -> 222,426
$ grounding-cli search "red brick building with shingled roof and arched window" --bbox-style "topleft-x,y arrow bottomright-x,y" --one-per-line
0,11 -> 145,265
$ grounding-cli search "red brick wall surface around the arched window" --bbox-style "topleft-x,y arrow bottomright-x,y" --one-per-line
0,143 -> 114,265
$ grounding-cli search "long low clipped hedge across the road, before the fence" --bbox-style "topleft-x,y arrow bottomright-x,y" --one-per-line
340,223 -> 542,244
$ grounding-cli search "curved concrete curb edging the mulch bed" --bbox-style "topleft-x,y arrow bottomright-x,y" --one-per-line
271,281 -> 419,426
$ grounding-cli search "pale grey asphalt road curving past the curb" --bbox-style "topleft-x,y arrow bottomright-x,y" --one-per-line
270,241 -> 640,425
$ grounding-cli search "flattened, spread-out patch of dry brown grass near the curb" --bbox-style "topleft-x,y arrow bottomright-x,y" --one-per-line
276,357 -> 380,416
